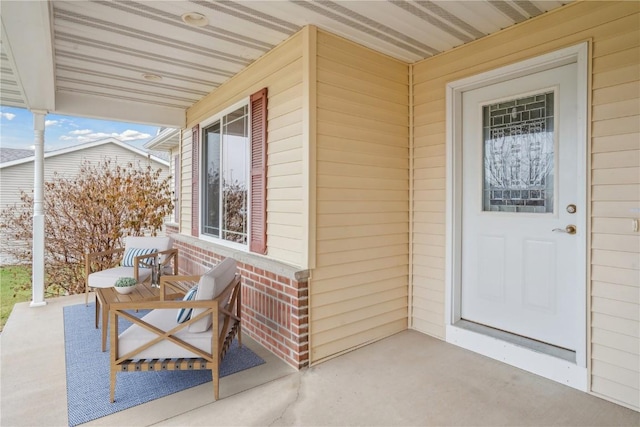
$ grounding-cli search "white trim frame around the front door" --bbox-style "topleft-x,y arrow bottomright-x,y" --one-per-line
444,42 -> 589,391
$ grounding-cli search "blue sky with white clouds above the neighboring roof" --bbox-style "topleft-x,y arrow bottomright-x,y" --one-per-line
0,107 -> 158,151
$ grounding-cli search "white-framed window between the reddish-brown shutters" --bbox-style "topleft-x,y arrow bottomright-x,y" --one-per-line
200,105 -> 250,245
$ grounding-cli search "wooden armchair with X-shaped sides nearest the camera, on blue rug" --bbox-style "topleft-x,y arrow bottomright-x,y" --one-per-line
109,258 -> 242,402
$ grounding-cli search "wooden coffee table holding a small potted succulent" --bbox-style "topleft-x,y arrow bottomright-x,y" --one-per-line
95,280 -> 184,351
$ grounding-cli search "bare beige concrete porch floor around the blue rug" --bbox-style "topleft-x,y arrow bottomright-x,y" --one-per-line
0,296 -> 640,426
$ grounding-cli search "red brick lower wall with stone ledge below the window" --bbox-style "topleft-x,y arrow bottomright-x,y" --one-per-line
165,226 -> 309,369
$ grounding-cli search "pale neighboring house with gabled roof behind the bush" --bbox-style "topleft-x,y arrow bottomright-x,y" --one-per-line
0,138 -> 169,263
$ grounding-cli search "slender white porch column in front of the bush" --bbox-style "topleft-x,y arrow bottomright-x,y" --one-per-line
31,110 -> 47,307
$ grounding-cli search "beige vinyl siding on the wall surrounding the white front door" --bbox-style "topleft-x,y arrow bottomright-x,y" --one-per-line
412,2 -> 640,408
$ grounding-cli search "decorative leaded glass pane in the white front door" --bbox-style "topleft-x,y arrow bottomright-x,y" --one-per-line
482,91 -> 555,213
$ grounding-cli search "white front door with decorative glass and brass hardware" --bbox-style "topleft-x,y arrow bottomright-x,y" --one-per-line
460,63 -> 586,351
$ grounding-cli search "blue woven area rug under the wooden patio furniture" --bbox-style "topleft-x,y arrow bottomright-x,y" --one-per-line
64,304 -> 265,426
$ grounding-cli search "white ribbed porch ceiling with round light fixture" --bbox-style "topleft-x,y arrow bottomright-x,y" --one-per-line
0,0 -> 568,127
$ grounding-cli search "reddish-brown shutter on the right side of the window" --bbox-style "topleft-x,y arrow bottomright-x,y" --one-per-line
249,88 -> 267,254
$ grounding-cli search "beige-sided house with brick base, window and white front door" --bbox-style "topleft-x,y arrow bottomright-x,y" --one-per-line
141,2 -> 640,410
